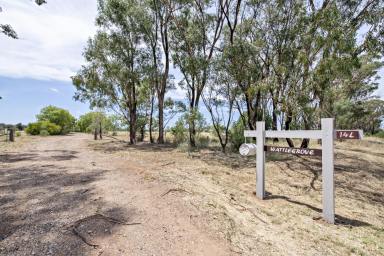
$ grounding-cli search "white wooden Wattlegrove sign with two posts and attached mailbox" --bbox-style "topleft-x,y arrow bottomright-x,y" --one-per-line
239,118 -> 362,223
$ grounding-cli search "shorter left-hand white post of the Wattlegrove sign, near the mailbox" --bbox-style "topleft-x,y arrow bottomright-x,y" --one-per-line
256,122 -> 265,199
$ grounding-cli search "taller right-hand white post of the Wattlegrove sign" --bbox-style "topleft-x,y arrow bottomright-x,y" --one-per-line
321,118 -> 335,224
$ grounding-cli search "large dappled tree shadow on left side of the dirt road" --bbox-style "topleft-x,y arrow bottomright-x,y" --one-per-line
0,159 -> 132,255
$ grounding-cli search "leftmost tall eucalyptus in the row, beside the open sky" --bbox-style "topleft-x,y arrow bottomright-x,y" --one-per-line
73,0 -> 147,144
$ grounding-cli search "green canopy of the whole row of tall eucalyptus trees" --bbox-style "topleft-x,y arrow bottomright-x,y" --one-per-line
72,0 -> 384,144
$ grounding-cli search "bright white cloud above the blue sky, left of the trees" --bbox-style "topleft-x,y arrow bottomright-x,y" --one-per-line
0,0 -> 97,81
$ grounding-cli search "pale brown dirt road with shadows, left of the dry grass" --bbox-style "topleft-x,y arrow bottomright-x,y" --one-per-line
0,134 -> 231,255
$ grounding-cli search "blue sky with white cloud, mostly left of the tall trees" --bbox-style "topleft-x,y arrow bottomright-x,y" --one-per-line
0,0 -> 384,124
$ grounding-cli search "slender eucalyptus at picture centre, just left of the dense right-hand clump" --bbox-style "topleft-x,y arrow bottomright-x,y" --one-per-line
170,0 -> 224,147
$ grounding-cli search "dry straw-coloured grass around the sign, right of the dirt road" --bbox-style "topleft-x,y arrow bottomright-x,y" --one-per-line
91,137 -> 384,255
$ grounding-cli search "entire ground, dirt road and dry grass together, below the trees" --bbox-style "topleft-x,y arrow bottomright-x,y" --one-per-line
0,134 -> 384,255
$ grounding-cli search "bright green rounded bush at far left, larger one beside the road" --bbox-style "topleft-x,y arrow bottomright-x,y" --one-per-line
36,106 -> 76,134
